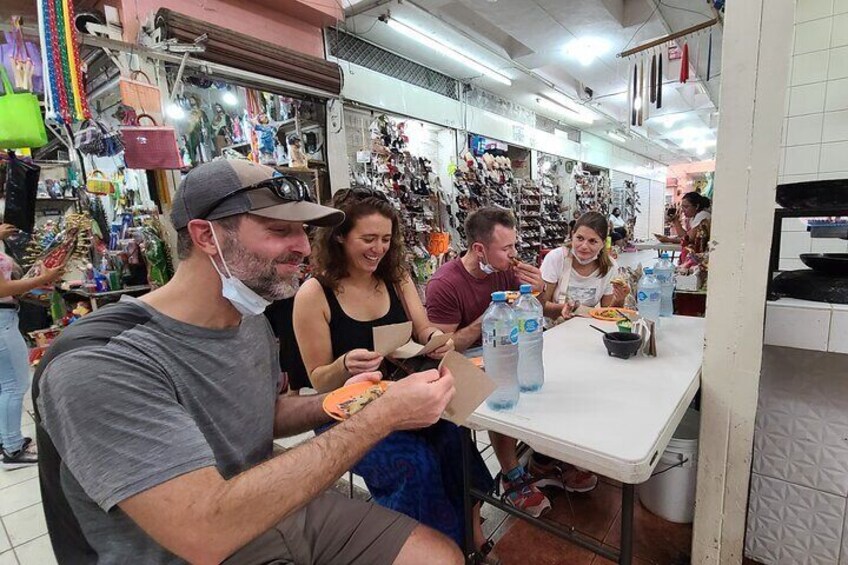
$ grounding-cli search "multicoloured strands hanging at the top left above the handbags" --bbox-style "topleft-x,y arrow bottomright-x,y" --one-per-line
37,0 -> 91,124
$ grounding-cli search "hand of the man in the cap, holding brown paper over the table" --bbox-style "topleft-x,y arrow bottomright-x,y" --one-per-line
374,368 -> 456,430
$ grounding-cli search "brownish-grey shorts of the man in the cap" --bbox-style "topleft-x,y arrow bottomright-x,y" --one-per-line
224,491 -> 418,565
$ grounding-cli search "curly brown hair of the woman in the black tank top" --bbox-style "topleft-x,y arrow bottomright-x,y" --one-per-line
312,188 -> 407,290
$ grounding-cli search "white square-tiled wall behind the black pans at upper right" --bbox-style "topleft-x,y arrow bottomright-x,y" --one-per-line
779,0 -> 848,269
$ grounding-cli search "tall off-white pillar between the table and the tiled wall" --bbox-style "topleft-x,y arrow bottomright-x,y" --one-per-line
692,0 -> 795,565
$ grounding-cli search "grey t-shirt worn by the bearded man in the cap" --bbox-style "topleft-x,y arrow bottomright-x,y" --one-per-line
37,297 -> 280,564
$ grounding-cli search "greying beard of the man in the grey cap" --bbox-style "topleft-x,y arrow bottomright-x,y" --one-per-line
221,239 -> 303,302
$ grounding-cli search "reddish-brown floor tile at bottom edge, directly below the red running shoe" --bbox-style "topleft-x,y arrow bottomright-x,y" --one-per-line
495,520 -> 595,565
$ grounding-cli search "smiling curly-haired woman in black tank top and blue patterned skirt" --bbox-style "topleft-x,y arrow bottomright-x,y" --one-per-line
294,189 -> 493,547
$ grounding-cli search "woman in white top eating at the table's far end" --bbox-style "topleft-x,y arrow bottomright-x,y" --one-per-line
542,212 -> 628,320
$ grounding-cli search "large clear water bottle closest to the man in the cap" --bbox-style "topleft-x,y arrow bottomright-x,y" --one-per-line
483,292 -> 519,410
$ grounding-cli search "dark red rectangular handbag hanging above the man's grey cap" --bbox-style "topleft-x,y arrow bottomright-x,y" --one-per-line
121,114 -> 183,170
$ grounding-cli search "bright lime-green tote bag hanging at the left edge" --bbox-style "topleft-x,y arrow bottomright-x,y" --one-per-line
0,63 -> 47,149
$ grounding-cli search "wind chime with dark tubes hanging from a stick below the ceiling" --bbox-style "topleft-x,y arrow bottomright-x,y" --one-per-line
618,19 -> 718,127
